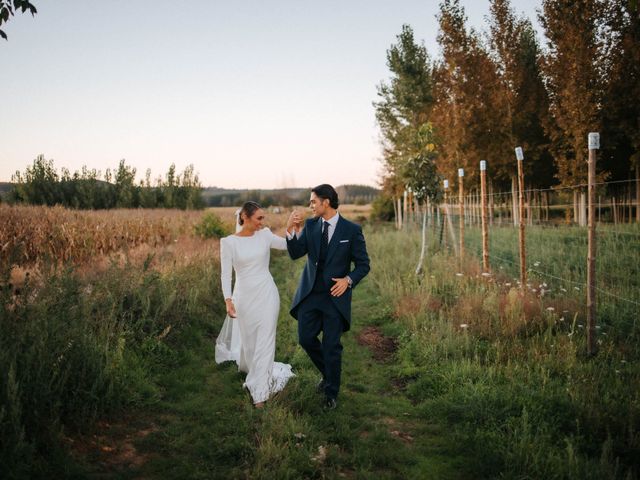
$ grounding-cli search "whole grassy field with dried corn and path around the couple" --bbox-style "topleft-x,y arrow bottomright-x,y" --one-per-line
0,206 -> 640,479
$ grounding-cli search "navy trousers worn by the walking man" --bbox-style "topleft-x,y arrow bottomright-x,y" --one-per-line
298,292 -> 344,399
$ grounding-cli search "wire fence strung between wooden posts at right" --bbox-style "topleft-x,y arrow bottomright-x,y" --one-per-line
402,182 -> 640,340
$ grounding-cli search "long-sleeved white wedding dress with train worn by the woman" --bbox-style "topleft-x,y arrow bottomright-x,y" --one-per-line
216,228 -> 294,403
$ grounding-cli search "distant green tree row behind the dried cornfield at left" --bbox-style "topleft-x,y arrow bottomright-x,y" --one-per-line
6,155 -> 204,210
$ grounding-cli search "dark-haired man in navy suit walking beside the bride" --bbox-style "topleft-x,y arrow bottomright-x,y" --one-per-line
287,184 -> 369,409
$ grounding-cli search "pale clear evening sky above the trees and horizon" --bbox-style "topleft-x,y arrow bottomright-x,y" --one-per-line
0,0 -> 540,189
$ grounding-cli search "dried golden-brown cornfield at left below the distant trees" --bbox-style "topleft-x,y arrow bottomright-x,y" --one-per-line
0,206 -> 202,272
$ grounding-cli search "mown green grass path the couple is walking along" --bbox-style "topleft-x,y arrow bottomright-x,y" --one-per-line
82,255 -> 472,479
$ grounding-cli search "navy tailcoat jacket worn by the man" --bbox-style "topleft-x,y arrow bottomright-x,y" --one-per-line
287,216 -> 369,331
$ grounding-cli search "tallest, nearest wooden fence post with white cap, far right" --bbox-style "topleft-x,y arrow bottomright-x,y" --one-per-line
587,132 -> 600,355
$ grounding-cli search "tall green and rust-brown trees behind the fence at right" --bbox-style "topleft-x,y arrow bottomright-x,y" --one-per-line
374,0 -> 640,221
